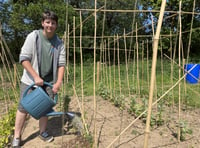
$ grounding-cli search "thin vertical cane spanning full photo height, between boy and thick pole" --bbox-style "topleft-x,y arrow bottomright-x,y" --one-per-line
93,0 -> 97,147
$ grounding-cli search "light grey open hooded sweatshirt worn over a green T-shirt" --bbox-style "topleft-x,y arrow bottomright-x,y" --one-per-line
19,30 -> 66,85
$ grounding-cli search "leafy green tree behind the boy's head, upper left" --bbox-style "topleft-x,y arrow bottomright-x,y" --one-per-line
0,0 -> 76,60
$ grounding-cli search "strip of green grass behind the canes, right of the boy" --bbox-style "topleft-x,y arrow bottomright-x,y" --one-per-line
62,60 -> 200,108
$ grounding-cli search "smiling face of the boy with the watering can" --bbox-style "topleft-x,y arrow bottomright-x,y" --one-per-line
42,19 -> 57,37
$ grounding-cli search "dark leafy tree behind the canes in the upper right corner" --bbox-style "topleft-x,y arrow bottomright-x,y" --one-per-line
141,0 -> 200,57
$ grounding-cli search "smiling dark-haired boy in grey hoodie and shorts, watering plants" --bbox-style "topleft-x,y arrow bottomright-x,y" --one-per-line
12,11 -> 66,147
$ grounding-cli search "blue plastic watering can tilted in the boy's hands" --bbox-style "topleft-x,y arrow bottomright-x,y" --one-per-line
20,82 -> 75,120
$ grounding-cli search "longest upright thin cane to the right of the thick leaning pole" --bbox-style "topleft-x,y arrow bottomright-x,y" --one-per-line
178,1 -> 182,142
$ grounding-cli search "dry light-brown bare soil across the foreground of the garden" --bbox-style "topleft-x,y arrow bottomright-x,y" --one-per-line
8,97 -> 200,148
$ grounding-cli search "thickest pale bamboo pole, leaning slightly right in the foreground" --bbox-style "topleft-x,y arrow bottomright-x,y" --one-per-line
144,0 -> 166,148
